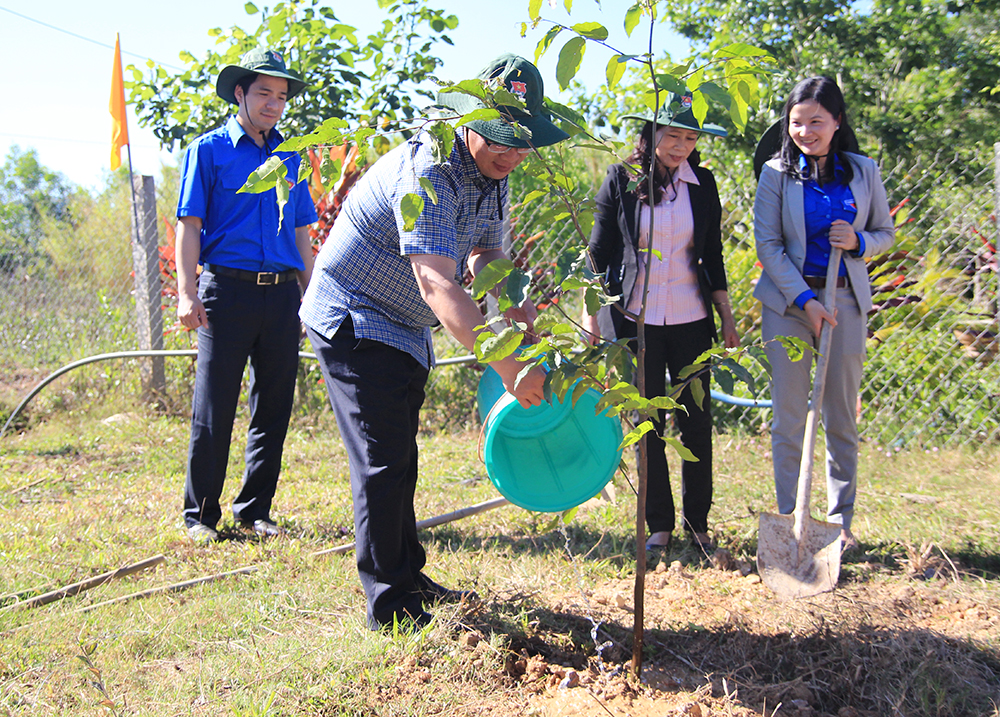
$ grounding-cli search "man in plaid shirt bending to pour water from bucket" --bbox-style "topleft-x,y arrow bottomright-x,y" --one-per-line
300,55 -> 567,630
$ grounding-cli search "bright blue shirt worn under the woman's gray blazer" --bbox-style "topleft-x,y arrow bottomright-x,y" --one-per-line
795,154 -> 865,309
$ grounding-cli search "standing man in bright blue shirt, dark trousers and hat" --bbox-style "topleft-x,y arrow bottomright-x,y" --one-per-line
177,49 -> 316,543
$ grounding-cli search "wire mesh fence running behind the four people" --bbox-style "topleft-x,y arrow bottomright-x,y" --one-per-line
0,145 -> 1000,450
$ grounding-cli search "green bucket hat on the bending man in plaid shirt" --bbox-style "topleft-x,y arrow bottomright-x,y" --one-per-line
437,54 -> 569,147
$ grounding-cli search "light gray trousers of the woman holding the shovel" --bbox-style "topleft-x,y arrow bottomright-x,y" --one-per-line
762,289 -> 867,530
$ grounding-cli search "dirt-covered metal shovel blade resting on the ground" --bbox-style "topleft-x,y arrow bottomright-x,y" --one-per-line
757,513 -> 840,600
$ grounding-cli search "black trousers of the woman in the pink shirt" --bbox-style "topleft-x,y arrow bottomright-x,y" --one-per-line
644,319 -> 712,534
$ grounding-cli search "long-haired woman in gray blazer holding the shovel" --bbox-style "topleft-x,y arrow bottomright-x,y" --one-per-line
754,77 -> 895,550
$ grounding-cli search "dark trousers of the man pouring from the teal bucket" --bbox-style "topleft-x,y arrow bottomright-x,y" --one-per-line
307,318 -> 428,629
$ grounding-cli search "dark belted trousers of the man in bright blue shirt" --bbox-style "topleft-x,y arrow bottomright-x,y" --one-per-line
184,272 -> 300,527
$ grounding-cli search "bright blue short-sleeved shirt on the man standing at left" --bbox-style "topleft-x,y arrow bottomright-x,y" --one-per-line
177,117 -> 317,271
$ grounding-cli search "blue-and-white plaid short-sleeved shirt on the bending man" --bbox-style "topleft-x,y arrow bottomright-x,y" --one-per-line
299,132 -> 507,368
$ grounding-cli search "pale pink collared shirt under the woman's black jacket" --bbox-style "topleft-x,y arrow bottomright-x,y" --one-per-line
627,162 -> 708,326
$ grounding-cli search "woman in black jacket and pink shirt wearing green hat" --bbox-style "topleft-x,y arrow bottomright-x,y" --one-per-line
584,95 -> 740,549
